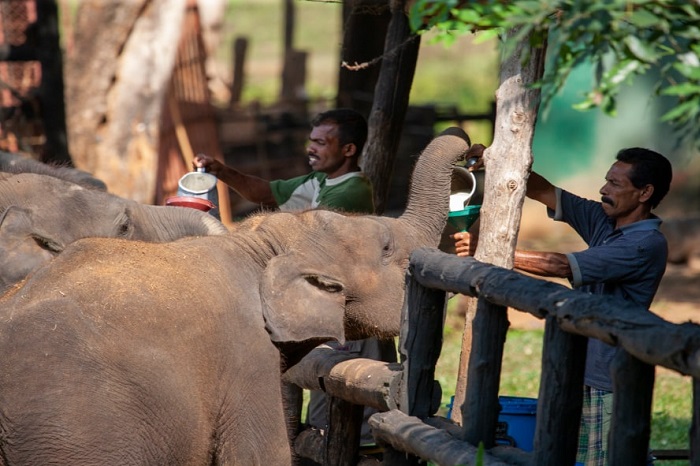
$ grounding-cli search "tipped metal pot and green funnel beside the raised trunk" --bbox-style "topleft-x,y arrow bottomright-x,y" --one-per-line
447,166 -> 483,235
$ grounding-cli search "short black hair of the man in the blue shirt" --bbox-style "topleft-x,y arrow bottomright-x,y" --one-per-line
616,147 -> 673,209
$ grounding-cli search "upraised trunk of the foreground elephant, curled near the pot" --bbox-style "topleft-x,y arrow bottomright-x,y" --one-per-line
399,127 -> 471,247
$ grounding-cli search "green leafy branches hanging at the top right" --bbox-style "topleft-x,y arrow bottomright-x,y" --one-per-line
410,0 -> 700,145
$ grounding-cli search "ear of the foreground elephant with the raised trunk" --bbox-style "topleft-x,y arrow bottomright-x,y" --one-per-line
260,254 -> 345,343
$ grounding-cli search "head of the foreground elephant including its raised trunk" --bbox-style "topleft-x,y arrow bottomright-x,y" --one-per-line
241,128 -> 476,358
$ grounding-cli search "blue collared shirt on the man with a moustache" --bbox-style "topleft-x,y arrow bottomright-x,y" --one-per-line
548,188 -> 668,391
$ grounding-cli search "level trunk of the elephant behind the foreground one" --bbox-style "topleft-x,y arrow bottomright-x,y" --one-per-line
129,204 -> 229,242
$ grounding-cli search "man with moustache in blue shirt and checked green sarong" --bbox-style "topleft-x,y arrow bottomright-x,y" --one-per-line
453,148 -> 672,465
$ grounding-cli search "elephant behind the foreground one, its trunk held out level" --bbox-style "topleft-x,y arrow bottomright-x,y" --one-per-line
0,172 -> 228,293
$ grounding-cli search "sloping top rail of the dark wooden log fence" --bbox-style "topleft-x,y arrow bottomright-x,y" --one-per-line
411,248 -> 700,378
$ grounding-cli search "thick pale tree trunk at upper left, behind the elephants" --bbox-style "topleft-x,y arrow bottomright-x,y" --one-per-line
65,0 -> 186,203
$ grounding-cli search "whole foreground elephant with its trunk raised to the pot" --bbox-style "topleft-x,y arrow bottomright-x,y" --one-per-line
0,129 -> 468,466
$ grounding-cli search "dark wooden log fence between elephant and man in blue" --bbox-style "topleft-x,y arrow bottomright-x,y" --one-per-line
285,249 -> 700,466
